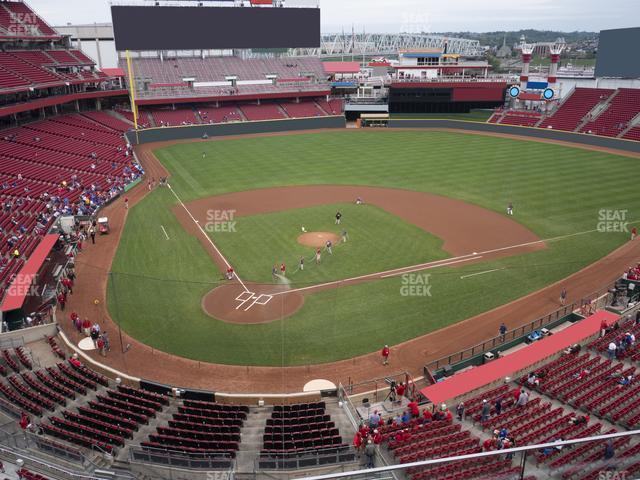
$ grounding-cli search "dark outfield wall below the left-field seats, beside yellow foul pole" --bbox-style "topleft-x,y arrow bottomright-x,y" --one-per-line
125,115 -> 346,145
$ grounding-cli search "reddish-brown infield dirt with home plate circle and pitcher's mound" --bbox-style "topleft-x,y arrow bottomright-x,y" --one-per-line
181,185 -> 545,324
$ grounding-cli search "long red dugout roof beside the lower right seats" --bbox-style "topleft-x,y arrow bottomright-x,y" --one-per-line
420,311 -> 619,403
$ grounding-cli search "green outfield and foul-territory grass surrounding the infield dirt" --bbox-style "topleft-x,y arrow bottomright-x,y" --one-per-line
109,130 -> 640,365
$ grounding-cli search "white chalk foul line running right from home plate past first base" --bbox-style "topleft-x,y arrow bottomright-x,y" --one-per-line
272,222 -> 608,297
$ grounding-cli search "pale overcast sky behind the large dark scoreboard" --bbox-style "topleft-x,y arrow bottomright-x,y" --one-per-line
29,0 -> 640,32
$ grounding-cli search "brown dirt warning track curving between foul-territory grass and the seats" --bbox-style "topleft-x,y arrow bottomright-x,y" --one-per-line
58,129 -> 640,393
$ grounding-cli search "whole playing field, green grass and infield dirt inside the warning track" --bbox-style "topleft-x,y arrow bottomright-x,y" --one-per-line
108,130 -> 640,366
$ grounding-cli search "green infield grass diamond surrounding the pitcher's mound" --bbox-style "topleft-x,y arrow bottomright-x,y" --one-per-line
211,204 -> 448,285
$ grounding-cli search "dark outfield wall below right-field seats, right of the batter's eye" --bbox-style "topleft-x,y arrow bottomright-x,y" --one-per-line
389,119 -> 640,153
